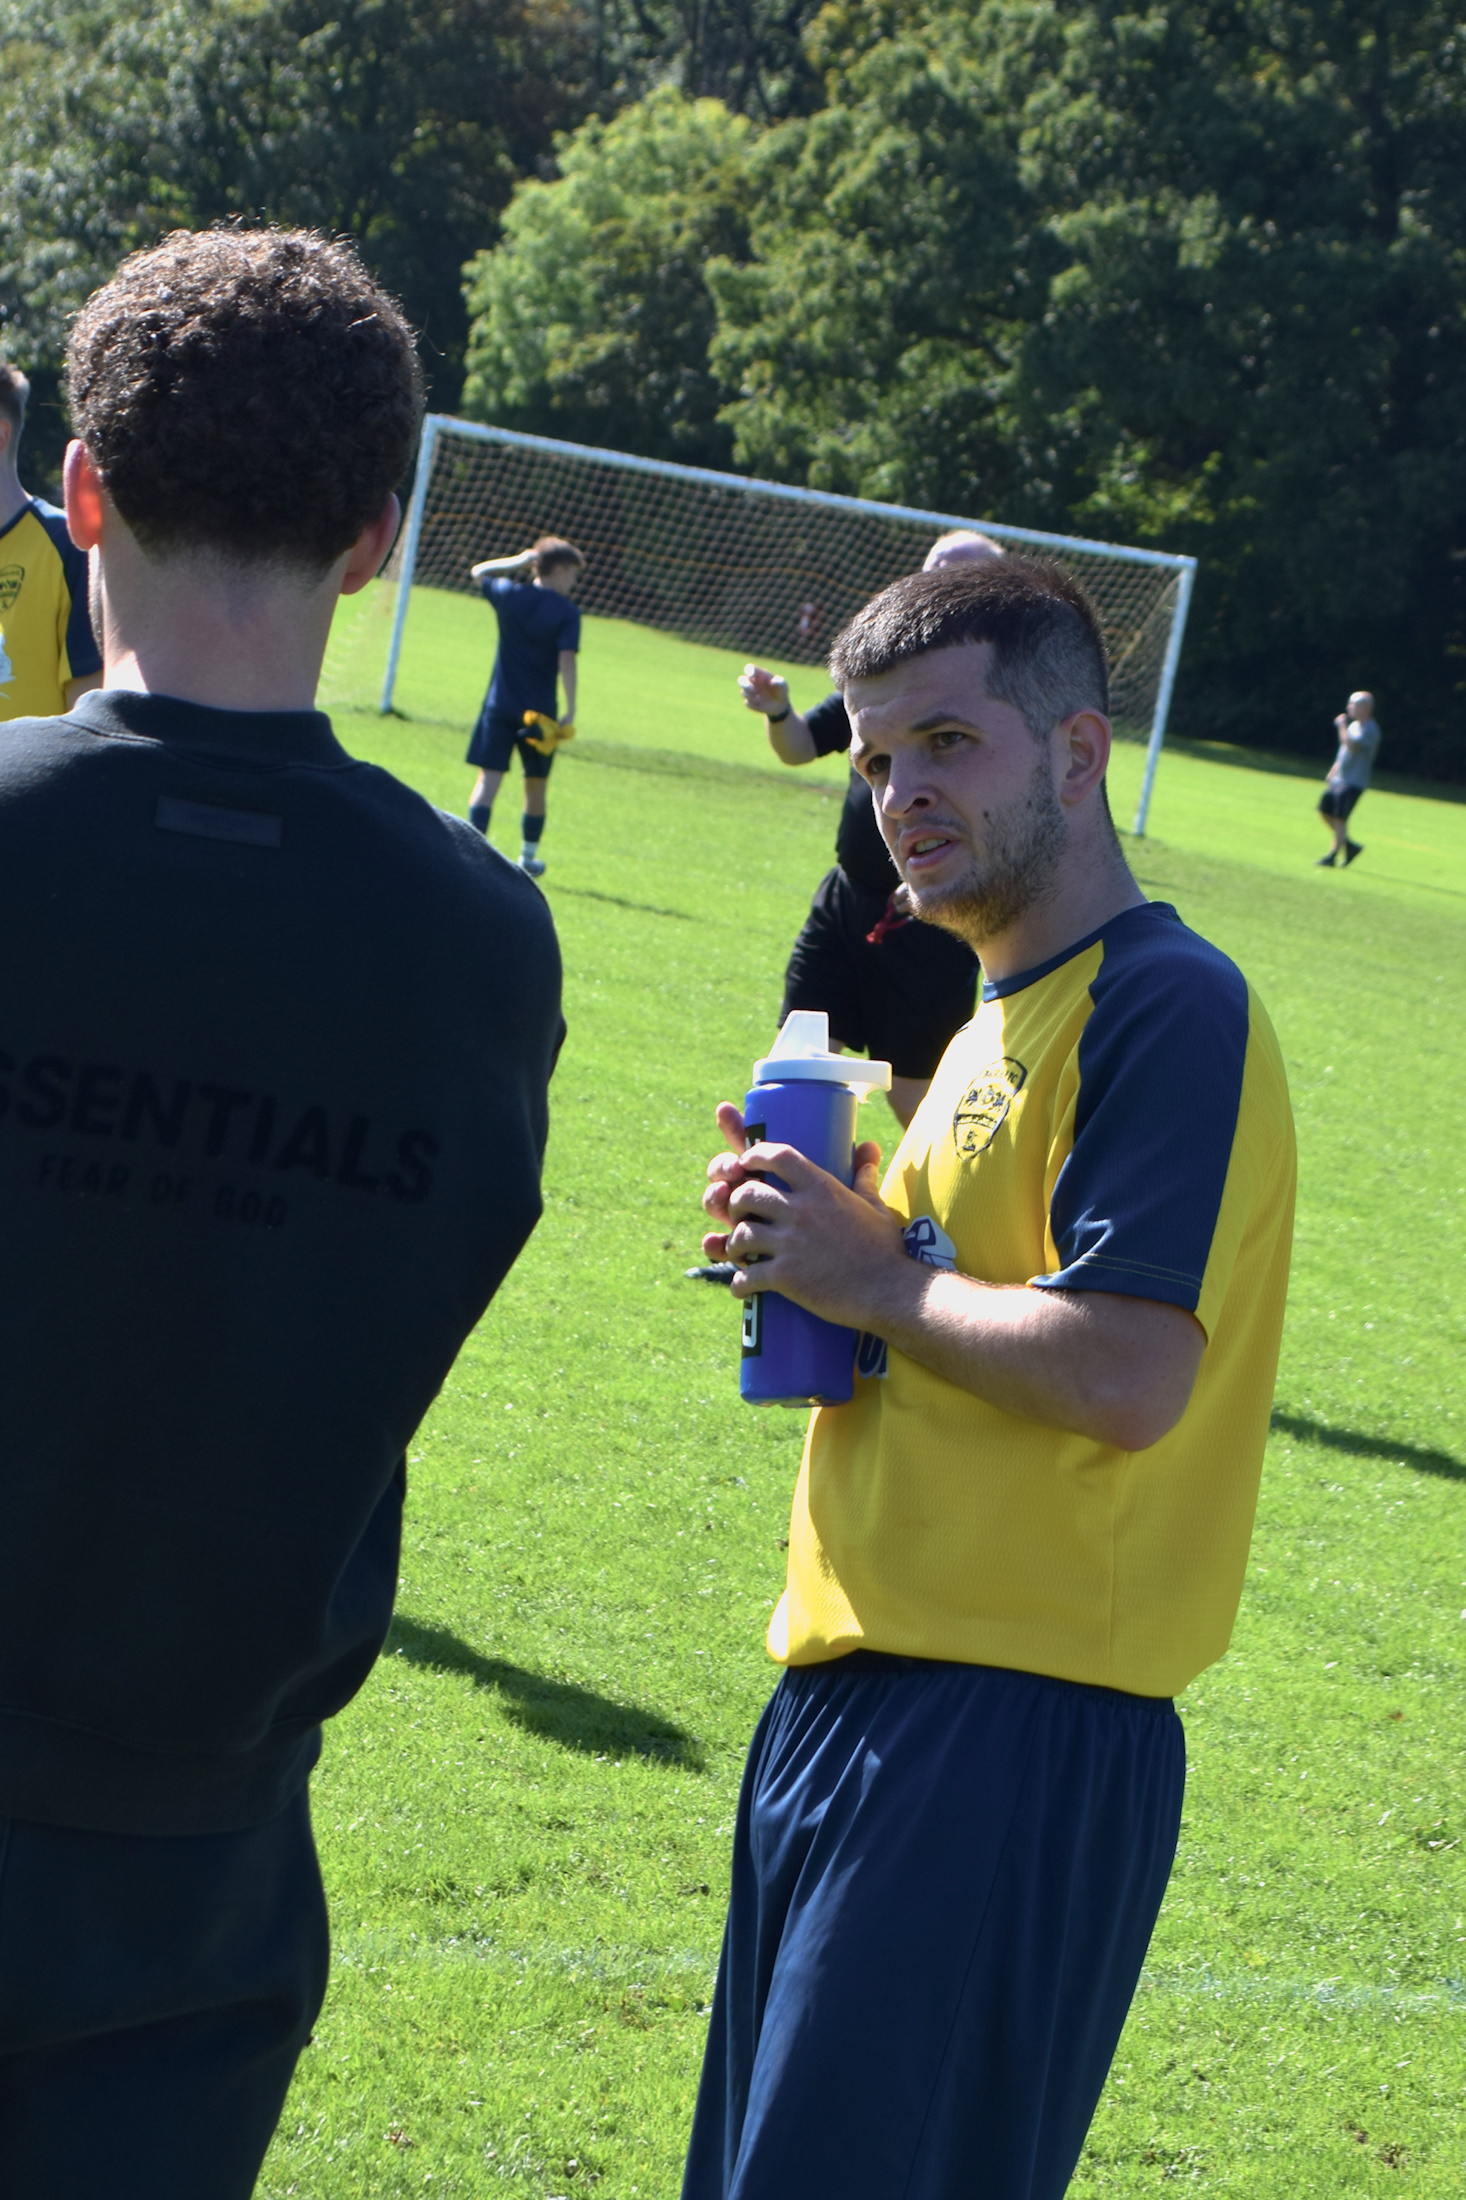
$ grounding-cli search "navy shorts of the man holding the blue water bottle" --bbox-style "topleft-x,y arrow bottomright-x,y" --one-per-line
682,1650 -> 1186,2200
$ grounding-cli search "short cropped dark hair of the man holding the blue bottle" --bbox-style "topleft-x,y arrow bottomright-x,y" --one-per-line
830,557 -> 1109,741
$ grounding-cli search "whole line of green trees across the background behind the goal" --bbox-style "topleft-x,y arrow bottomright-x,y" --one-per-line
0,0 -> 1466,779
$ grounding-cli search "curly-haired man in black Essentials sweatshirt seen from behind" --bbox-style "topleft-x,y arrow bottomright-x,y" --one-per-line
0,231 -> 564,2200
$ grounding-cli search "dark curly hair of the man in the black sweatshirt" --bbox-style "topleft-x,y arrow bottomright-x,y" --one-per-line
66,229 -> 423,572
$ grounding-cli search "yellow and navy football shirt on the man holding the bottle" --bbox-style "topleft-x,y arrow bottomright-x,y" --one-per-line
768,902 -> 1294,1696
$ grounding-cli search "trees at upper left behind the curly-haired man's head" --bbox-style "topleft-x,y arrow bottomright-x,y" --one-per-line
0,0 -> 583,464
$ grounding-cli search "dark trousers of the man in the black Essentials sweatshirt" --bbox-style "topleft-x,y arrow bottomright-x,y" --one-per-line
0,1793 -> 330,2200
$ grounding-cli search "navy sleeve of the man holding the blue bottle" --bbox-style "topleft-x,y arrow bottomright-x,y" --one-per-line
1035,911 -> 1248,1313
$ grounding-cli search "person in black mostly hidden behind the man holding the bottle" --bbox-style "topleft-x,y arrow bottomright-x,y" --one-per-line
737,528 -> 1004,1131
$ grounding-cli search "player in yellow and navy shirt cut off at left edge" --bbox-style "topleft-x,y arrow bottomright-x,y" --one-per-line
0,359 -> 101,719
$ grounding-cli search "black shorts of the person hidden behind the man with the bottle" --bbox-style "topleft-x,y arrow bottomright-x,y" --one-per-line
779,865 -> 977,1078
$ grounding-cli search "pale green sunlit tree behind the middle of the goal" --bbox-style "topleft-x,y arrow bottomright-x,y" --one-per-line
462,86 -> 751,466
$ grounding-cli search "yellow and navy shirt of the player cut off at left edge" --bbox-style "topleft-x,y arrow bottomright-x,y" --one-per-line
0,497 -> 101,719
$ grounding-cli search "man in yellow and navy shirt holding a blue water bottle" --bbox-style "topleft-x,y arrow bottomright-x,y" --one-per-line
685,557 -> 1294,2200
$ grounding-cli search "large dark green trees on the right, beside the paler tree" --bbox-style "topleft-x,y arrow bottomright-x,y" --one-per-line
709,0 -> 1466,777
